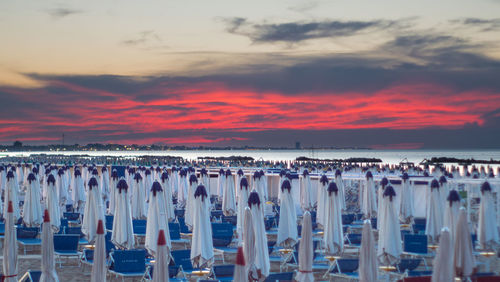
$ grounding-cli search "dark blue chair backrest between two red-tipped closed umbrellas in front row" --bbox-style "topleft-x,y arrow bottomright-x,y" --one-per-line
111,249 -> 146,273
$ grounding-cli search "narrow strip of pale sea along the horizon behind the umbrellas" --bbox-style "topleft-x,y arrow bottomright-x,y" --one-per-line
0,149 -> 500,164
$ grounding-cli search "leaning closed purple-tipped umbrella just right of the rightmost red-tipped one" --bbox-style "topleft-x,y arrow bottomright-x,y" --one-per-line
245,191 -> 271,280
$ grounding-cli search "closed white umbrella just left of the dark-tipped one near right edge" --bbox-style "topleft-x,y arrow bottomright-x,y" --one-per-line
425,179 -> 443,242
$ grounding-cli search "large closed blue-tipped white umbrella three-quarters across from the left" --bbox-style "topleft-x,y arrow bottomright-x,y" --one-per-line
377,185 -> 403,265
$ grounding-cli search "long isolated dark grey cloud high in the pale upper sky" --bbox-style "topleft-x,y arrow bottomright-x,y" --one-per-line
224,18 -> 404,44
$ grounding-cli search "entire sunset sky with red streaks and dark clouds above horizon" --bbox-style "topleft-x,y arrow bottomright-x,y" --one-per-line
0,0 -> 500,149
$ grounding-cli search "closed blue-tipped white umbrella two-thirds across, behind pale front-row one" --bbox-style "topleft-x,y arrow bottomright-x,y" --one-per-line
323,181 -> 344,255
